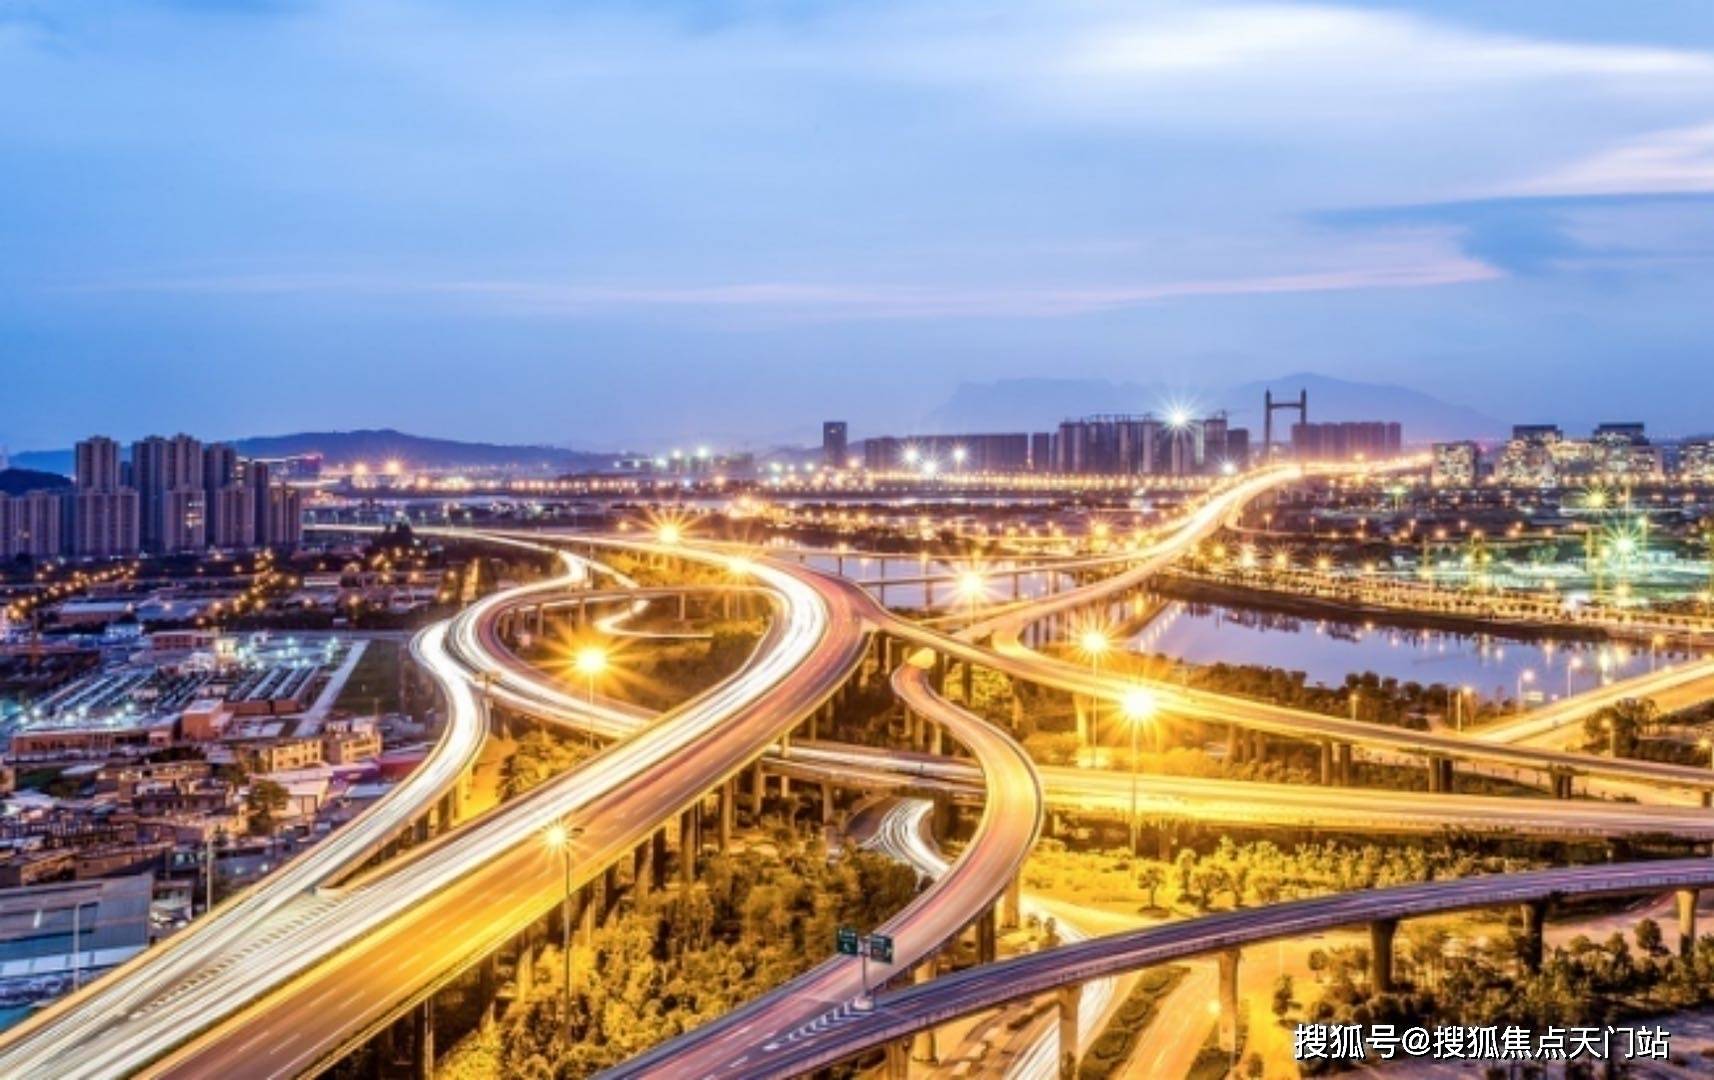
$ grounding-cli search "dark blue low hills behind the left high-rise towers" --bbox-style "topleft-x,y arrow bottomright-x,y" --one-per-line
12,429 -> 614,475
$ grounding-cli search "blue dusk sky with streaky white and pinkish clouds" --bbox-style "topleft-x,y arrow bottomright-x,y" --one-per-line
0,0 -> 1714,451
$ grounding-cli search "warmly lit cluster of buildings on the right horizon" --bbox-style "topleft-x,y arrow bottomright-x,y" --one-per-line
1433,422 -> 1714,487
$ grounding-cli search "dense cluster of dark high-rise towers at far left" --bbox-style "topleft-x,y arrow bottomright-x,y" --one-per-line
0,435 -> 303,559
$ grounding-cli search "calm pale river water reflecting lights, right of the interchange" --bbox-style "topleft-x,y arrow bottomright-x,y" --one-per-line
1131,600 -> 1683,701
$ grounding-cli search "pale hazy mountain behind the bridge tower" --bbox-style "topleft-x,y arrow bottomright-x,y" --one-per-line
925,372 -> 1508,442
